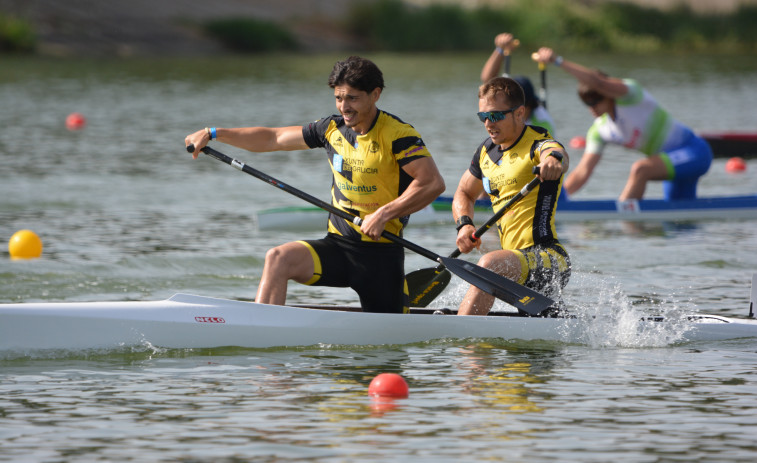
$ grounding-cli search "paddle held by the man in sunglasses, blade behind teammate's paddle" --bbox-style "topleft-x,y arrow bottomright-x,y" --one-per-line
405,170 -> 554,307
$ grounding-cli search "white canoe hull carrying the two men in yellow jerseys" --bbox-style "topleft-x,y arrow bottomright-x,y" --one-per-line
0,294 -> 757,351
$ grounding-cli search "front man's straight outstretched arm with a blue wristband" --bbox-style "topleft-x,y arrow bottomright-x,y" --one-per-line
184,125 -> 309,159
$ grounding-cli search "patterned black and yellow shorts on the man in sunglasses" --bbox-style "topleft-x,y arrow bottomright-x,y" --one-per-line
513,241 -> 571,298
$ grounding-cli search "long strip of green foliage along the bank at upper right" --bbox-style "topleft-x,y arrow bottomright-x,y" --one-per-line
347,0 -> 757,52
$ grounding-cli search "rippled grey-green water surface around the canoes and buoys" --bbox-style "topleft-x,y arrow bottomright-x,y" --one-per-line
0,55 -> 757,462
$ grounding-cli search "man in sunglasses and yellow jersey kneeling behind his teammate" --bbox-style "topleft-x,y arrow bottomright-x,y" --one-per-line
452,77 -> 571,315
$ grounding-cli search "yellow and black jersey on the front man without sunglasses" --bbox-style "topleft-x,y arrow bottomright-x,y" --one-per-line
302,110 -> 431,242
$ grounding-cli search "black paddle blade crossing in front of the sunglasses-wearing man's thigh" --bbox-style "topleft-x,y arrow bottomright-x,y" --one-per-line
439,257 -> 555,315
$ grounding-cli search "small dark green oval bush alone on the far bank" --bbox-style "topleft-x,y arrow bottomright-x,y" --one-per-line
205,18 -> 297,53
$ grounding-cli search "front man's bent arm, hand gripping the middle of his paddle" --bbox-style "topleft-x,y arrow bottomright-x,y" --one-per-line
360,157 -> 445,240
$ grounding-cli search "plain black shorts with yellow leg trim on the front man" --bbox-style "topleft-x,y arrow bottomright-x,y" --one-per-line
298,233 -> 409,313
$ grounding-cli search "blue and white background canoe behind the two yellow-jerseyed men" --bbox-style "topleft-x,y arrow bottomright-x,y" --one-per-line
256,195 -> 757,230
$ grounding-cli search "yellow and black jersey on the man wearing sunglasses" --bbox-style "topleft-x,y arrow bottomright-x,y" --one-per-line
469,125 -> 563,249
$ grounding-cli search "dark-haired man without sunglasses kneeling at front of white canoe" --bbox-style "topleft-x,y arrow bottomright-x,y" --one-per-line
184,56 -> 444,313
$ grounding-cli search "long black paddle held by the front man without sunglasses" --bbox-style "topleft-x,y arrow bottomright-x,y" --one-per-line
187,145 -> 554,315
